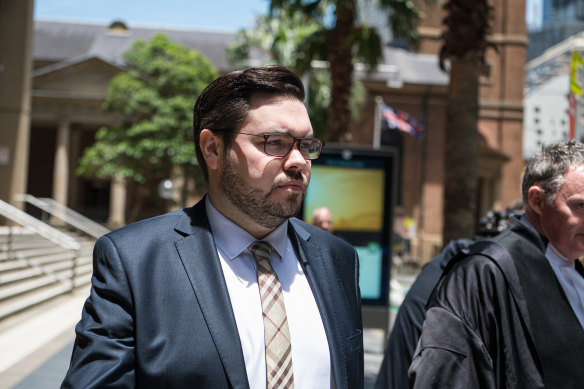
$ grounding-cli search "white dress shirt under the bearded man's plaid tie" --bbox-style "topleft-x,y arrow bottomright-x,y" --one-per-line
205,197 -> 334,389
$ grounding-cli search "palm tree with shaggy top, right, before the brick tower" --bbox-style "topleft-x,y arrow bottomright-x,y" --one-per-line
440,0 -> 492,244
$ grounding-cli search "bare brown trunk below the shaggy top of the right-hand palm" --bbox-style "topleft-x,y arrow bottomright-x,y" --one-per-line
442,56 -> 480,245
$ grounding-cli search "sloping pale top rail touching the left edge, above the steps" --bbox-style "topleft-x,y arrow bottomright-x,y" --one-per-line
0,200 -> 81,251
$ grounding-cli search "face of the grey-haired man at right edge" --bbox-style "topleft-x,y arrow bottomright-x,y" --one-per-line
540,166 -> 584,259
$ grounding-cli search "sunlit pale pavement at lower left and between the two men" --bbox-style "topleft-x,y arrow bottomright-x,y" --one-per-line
0,290 -> 392,389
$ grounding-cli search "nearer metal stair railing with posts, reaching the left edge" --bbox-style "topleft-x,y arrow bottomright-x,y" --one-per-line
0,200 -> 81,291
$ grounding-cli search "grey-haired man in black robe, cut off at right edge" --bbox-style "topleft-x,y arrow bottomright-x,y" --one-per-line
409,141 -> 584,389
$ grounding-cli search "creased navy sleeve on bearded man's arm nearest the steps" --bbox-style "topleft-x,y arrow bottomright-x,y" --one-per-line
61,236 -> 136,389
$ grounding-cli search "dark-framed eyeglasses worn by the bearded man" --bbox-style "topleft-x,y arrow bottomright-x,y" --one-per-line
214,130 -> 325,159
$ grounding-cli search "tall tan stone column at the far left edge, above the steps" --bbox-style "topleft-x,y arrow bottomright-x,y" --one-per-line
0,0 -> 34,207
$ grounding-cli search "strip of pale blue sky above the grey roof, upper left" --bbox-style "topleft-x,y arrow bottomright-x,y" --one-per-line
34,0 -> 269,32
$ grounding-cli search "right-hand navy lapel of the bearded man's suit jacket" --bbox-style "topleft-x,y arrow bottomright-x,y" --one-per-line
288,222 -> 348,388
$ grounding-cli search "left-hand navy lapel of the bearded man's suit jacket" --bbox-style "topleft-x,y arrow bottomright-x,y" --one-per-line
175,199 -> 249,389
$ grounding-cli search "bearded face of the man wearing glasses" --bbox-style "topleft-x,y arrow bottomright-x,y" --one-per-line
220,95 -> 313,228
